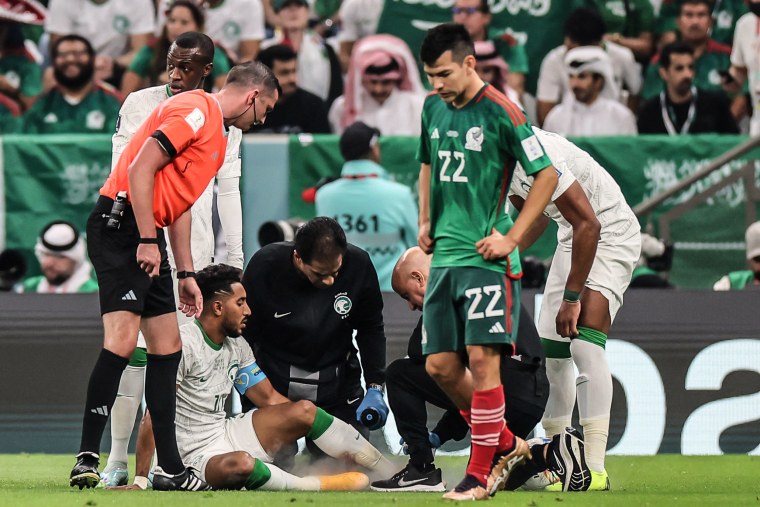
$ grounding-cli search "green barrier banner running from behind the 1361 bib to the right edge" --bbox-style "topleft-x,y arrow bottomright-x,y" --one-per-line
289,135 -> 760,288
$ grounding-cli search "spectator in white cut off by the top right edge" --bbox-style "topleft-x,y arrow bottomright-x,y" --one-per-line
723,0 -> 760,136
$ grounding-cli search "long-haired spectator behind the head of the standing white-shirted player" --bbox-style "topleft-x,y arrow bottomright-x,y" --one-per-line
121,0 -> 230,96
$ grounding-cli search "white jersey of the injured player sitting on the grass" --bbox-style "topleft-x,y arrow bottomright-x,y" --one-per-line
175,321 -> 256,458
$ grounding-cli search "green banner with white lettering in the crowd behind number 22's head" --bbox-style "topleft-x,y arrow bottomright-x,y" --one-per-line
377,0 -> 593,93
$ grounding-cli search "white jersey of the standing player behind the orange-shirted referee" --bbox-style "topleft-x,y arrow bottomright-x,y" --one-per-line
111,85 -> 243,271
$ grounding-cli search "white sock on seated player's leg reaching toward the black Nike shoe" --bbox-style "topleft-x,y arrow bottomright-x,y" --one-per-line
313,417 -> 396,476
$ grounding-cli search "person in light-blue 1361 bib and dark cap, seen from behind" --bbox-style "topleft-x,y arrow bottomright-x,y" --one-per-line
315,122 -> 417,292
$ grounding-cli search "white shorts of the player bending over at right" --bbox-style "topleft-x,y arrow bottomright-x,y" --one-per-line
538,231 -> 641,342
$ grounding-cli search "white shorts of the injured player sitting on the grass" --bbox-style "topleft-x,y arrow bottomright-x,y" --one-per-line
180,410 -> 274,481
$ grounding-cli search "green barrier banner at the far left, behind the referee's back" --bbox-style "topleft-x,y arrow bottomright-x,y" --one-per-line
2,134 -> 111,275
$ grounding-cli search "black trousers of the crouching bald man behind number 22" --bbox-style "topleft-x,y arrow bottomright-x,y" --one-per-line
386,358 -> 549,467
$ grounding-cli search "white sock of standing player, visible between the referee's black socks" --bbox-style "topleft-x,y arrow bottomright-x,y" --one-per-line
108,366 -> 145,464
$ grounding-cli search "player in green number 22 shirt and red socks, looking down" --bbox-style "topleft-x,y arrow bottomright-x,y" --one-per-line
417,23 -> 560,500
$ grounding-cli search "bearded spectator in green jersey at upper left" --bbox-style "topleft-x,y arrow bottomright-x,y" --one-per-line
21,35 -> 121,134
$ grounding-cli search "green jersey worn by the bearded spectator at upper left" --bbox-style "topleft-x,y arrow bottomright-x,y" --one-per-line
21,85 -> 121,134
